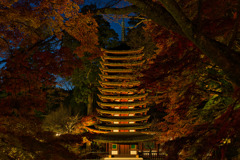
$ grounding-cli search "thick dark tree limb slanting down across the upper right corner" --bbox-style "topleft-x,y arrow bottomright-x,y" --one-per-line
159,0 -> 240,86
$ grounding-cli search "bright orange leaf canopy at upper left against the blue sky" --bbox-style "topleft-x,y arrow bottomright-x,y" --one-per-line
0,0 -> 98,56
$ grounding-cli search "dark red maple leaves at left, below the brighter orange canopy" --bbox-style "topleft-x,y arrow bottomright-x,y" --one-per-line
0,47 -> 81,113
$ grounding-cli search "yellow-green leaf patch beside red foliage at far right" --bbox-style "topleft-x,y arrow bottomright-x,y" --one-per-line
194,65 -> 234,122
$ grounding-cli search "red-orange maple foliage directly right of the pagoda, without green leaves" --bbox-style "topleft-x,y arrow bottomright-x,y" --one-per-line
143,23 -> 208,143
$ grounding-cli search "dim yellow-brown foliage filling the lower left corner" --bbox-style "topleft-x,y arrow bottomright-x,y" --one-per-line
0,115 -> 82,160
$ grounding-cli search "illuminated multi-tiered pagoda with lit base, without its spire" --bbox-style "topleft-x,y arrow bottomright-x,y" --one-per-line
95,44 -> 153,159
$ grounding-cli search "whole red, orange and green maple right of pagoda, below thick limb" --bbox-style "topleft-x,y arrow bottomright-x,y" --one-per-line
139,12 -> 239,159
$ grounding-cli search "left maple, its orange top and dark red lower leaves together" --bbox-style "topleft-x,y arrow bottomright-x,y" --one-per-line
0,0 -> 99,113
